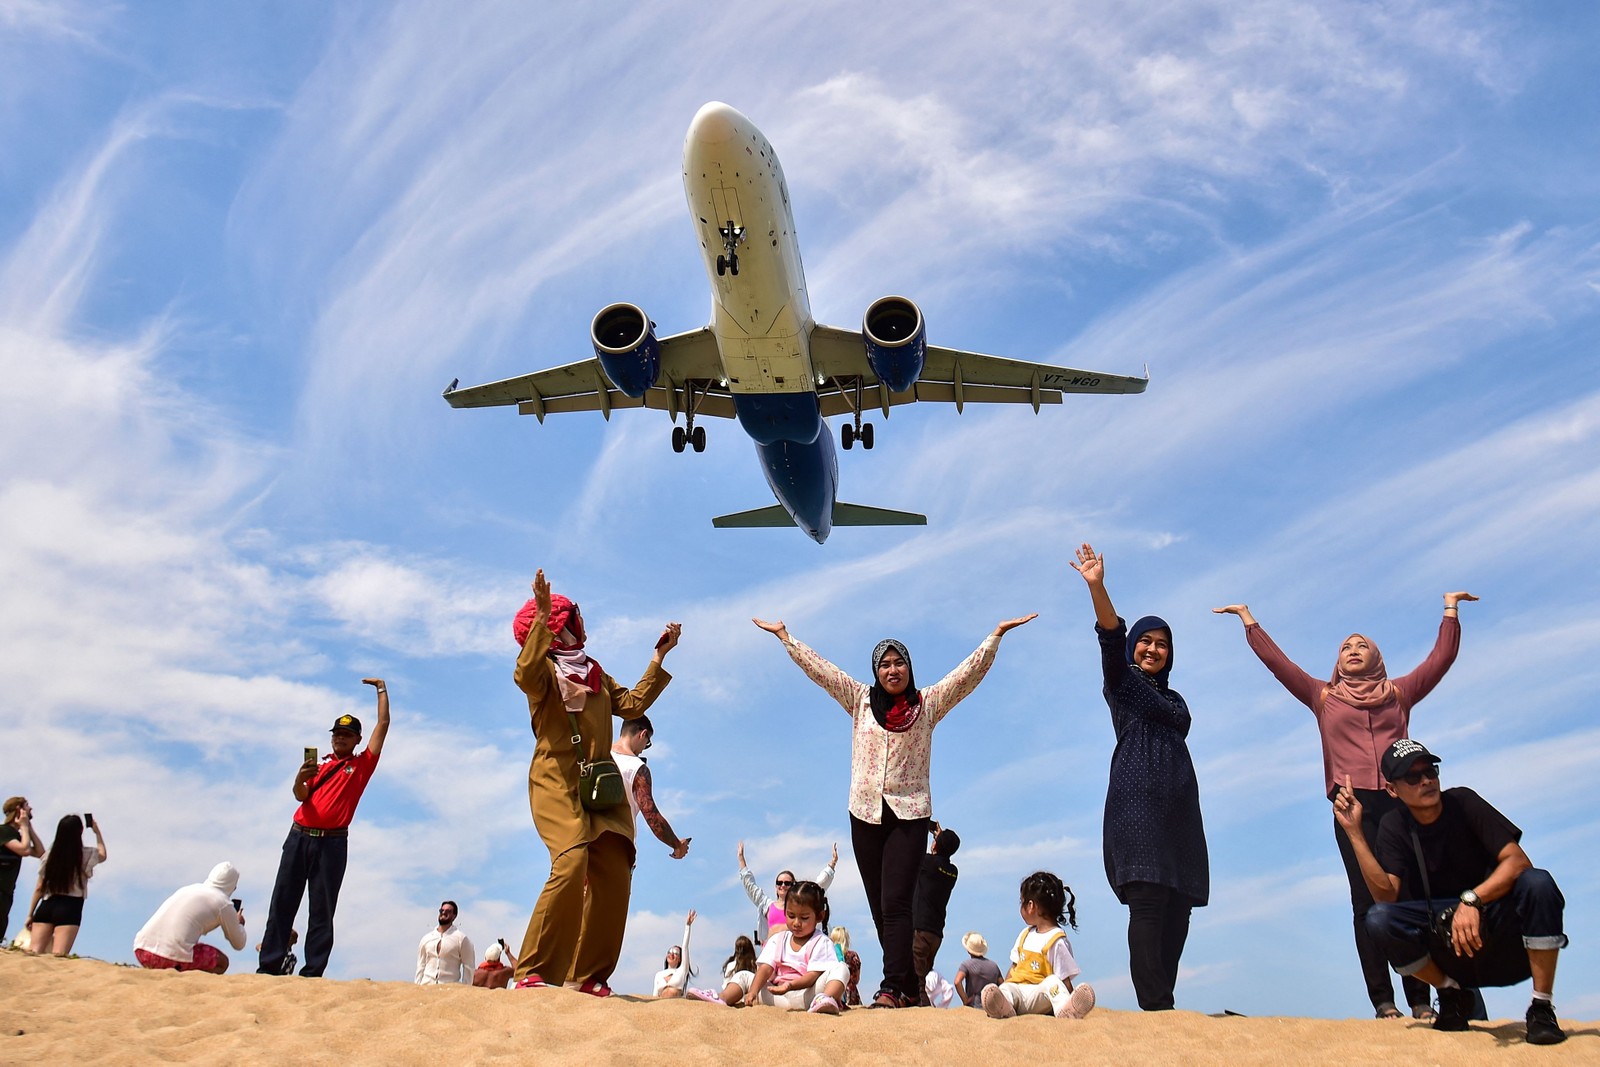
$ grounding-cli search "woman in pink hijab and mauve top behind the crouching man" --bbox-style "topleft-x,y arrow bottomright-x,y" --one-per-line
1213,592 -> 1477,1019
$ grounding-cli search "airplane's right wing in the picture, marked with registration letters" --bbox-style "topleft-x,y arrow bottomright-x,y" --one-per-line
811,325 -> 1149,416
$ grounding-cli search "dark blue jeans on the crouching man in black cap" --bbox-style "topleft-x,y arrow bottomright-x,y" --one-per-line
1366,867 -> 1566,989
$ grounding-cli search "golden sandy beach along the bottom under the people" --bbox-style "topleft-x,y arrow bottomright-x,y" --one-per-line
0,952 -> 1600,1067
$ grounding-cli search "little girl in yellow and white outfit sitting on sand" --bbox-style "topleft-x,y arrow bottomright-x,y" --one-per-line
982,870 -> 1094,1019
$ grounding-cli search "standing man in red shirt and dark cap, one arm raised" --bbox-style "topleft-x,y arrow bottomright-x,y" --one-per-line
256,678 -> 389,977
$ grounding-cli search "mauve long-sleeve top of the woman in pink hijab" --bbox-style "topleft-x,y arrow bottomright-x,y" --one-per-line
1245,614 -> 1461,797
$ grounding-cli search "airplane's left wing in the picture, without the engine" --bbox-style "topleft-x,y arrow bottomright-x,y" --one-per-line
445,326 -> 734,422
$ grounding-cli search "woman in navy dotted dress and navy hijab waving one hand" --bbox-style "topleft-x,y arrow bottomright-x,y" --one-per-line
1072,544 -> 1211,1011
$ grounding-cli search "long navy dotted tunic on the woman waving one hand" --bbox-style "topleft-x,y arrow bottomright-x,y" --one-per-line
1094,619 -> 1211,907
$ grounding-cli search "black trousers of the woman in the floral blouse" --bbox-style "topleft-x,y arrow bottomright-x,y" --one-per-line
850,803 -> 931,1003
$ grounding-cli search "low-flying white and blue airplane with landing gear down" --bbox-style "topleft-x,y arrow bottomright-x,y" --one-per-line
443,101 -> 1149,544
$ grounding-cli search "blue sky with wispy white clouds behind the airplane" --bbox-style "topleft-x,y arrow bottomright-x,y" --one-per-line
0,0 -> 1600,1019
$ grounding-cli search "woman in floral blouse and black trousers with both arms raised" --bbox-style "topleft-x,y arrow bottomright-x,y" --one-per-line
752,614 -> 1038,1008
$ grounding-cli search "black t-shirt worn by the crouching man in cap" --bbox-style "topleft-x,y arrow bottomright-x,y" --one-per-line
1373,785 -> 1522,901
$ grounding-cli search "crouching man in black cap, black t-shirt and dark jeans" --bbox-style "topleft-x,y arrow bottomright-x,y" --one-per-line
1334,737 -> 1566,1045
